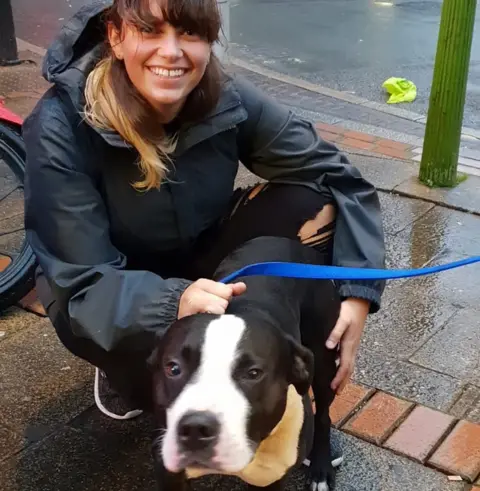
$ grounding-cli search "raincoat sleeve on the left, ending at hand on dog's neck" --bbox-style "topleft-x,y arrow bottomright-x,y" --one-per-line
24,94 -> 190,351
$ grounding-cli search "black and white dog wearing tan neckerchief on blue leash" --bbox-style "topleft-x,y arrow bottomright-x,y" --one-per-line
150,237 -> 340,491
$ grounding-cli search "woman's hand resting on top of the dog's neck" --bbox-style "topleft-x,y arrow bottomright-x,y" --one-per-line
177,278 -> 247,319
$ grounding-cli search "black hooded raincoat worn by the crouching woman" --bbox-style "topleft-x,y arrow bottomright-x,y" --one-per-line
24,1 -> 384,350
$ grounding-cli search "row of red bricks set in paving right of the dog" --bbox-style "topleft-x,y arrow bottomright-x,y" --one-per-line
330,383 -> 480,484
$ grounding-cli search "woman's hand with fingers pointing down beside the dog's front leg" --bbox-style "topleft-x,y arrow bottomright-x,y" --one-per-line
326,298 -> 370,393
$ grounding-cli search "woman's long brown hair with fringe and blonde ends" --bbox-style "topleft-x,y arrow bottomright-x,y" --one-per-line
85,0 -> 222,190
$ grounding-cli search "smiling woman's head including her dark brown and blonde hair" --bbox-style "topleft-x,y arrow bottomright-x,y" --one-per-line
85,0 -> 221,190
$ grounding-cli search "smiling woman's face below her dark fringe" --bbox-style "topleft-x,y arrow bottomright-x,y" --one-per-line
108,1 -> 211,122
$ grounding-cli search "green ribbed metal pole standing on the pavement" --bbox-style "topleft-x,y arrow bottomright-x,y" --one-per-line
419,0 -> 477,187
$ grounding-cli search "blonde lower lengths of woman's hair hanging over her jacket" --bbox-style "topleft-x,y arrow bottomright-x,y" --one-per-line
84,56 -> 177,191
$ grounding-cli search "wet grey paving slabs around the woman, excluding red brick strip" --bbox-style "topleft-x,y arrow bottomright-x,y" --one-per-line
0,45 -> 480,491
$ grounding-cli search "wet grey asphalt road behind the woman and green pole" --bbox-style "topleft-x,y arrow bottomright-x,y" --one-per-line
12,0 -> 480,128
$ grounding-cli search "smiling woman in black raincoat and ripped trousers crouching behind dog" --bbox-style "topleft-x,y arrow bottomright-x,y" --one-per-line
23,0 -> 384,484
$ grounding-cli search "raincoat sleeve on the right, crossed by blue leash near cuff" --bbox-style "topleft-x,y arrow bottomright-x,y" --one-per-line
234,78 -> 385,312
